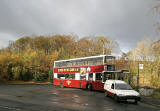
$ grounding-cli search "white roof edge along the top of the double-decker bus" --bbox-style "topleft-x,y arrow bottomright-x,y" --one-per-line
54,55 -> 115,62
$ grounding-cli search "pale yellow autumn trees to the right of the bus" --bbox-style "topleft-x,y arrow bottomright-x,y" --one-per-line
129,39 -> 160,87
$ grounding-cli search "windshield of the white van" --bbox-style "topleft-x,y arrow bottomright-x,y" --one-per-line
115,83 -> 132,90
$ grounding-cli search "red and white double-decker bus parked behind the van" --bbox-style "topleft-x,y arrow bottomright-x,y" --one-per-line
54,55 -> 126,91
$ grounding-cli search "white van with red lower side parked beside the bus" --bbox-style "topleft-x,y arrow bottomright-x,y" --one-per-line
104,80 -> 140,103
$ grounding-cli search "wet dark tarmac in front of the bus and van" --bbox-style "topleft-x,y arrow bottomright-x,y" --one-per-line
0,85 -> 160,111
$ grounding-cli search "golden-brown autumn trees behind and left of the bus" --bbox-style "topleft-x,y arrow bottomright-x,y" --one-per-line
0,35 -> 118,81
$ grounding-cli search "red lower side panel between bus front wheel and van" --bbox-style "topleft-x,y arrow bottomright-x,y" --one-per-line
91,81 -> 104,91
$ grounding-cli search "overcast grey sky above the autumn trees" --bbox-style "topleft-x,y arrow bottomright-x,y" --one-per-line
0,0 -> 158,52
